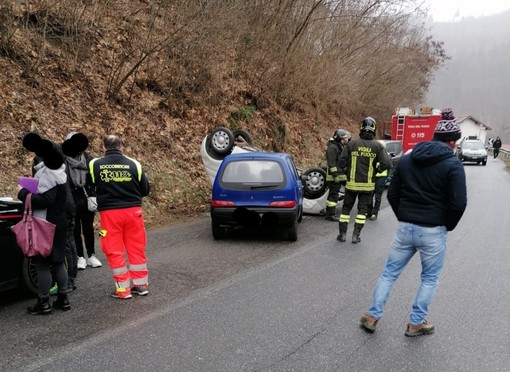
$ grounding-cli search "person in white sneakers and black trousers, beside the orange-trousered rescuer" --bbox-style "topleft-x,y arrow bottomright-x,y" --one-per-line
62,132 -> 102,270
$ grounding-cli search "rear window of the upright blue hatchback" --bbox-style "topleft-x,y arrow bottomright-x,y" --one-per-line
221,159 -> 285,189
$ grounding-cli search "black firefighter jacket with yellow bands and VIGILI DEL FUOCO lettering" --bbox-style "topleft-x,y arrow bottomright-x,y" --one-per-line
340,133 -> 391,192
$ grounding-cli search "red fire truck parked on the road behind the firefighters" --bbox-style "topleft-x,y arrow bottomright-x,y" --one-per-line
383,107 -> 441,152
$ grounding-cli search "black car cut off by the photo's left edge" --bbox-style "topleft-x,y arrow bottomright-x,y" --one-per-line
0,197 -> 37,294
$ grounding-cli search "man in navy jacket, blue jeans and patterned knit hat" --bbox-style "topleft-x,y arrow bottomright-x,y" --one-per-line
360,108 -> 467,337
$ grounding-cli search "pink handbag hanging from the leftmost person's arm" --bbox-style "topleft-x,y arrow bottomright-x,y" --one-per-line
11,194 -> 56,257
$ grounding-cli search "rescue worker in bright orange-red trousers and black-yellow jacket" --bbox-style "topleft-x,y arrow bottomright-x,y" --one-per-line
89,135 -> 150,300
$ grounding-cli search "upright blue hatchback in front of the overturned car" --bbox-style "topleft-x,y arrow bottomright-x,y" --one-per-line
211,152 -> 304,241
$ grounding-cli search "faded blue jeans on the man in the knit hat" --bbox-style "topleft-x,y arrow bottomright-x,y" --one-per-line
369,222 -> 447,325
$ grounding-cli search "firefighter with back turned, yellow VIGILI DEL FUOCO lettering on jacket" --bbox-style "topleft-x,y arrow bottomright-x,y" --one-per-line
337,117 -> 391,244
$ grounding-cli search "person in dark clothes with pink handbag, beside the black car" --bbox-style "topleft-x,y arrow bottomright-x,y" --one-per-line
18,132 -> 71,315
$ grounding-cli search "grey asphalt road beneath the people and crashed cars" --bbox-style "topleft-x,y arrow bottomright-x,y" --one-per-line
0,159 -> 510,371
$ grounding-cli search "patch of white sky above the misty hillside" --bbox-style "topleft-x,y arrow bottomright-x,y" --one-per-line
425,0 -> 510,22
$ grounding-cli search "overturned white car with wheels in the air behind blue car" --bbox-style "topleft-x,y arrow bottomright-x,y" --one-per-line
200,127 -> 329,215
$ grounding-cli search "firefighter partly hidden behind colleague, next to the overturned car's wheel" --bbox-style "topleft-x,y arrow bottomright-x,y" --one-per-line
326,129 -> 351,221
